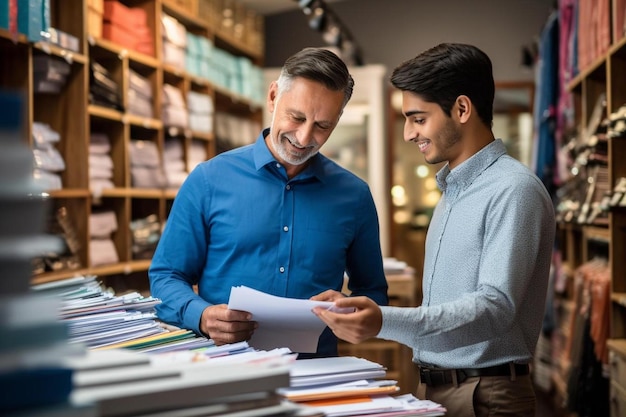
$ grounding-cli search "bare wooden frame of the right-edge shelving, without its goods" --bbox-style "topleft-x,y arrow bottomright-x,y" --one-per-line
553,0 -> 626,417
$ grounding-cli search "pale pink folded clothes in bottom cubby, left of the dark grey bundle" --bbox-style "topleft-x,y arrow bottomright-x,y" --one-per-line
89,210 -> 119,266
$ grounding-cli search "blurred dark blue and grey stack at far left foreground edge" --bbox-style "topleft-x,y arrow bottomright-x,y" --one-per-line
0,92 -> 96,417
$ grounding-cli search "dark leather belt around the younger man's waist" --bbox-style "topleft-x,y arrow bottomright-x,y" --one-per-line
418,363 -> 530,387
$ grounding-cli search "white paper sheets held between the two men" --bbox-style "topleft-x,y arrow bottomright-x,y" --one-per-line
228,286 -> 334,353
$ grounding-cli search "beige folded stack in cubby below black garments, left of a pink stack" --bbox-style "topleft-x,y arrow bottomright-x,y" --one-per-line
89,132 -> 115,195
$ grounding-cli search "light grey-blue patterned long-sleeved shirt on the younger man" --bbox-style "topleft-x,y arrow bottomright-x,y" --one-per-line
378,139 -> 555,368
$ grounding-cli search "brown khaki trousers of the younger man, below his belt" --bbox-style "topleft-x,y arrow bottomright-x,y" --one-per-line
417,375 -> 537,417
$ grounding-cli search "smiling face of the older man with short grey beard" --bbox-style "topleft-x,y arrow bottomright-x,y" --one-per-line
266,77 -> 344,178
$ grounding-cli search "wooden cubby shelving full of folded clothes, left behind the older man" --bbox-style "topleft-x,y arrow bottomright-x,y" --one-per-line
0,0 -> 265,290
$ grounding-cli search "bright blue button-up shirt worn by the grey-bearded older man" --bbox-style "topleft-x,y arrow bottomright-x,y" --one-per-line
149,130 -> 388,355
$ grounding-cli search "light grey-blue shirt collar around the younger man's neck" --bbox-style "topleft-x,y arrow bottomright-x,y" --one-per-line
435,139 -> 506,191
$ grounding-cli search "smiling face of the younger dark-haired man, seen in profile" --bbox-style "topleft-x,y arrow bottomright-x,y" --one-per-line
402,91 -> 466,168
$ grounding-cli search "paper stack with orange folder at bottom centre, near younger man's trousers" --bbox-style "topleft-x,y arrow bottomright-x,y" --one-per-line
278,356 -> 446,417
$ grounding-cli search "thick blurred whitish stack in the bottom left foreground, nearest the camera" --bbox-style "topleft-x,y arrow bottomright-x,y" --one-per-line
64,349 -> 301,417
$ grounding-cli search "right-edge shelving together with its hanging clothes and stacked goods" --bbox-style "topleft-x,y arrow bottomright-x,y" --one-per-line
540,0 -> 626,417
